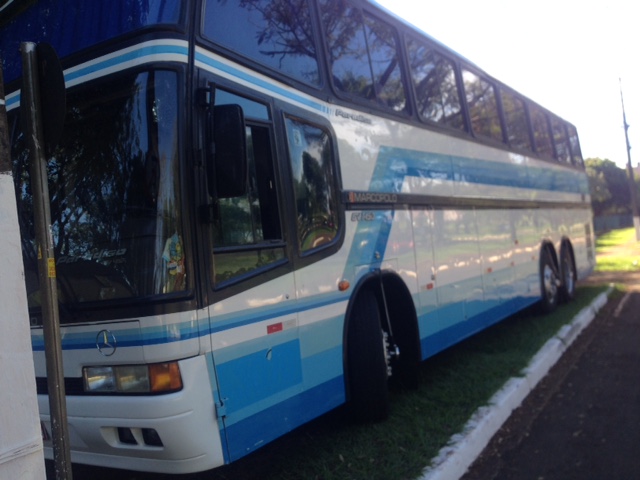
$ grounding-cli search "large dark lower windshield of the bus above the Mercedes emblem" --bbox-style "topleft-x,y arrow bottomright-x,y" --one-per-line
11,70 -> 187,314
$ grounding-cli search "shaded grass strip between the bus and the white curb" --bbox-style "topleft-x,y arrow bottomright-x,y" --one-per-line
214,287 -> 603,480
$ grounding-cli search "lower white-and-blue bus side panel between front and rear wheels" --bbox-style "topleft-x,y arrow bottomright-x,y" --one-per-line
414,206 -> 548,358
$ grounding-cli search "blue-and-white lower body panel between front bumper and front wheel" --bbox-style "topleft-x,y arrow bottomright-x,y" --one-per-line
205,270 -> 347,462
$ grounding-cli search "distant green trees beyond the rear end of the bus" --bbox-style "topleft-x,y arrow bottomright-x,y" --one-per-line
585,158 -> 631,216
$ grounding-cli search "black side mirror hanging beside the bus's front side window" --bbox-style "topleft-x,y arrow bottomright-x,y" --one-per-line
207,105 -> 248,198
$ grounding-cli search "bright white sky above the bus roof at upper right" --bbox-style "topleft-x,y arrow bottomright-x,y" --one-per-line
377,0 -> 640,167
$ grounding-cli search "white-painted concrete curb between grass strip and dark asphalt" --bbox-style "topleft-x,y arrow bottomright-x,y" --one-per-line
418,287 -> 613,480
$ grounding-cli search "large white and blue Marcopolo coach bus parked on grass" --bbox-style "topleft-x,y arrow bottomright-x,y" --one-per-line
0,0 -> 595,473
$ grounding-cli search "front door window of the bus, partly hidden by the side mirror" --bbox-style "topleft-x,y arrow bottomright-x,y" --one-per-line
211,90 -> 286,286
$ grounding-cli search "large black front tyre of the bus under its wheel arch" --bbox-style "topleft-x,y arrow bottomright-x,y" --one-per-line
347,290 -> 389,423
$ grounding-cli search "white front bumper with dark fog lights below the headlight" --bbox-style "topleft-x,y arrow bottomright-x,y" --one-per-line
38,356 -> 224,473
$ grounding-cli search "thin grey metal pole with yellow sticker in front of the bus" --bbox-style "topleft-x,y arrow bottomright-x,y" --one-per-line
20,42 -> 72,480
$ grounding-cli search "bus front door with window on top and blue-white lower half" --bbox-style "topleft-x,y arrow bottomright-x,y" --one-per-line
199,84 -> 302,461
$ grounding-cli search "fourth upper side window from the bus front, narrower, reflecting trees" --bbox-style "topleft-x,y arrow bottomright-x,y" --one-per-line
462,70 -> 502,141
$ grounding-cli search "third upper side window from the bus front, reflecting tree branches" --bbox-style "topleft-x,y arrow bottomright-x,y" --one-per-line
407,39 -> 465,130
